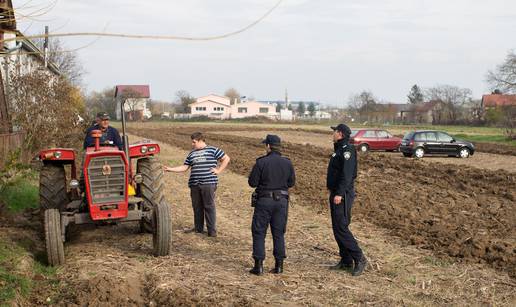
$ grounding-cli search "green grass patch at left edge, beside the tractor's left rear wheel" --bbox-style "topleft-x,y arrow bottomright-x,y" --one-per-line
0,174 -> 39,213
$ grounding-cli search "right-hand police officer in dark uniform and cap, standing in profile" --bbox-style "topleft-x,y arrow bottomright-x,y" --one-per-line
326,124 -> 367,276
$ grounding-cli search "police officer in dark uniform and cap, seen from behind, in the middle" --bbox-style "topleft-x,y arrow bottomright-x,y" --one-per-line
249,134 -> 296,275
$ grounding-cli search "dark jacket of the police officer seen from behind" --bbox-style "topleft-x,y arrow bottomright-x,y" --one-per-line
248,151 -> 296,192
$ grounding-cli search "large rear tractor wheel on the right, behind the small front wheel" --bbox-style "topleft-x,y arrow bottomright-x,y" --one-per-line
136,157 -> 165,233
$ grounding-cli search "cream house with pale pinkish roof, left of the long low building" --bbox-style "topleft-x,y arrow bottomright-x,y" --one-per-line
188,94 -> 231,119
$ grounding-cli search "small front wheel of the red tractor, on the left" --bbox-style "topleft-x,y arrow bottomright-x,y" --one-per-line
44,209 -> 65,266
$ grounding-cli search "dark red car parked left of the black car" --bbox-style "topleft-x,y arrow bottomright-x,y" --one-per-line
349,129 -> 401,152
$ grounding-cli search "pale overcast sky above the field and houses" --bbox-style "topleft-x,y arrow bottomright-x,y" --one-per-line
13,0 -> 516,106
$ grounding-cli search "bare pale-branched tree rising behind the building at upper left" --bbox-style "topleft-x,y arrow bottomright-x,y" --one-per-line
34,37 -> 85,86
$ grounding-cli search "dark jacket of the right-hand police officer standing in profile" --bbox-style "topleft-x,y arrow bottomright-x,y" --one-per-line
326,140 -> 357,196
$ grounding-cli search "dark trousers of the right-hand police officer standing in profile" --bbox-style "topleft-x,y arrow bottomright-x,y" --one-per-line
330,192 -> 362,264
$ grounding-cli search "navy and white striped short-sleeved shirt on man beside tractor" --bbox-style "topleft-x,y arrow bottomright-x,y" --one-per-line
184,146 -> 225,187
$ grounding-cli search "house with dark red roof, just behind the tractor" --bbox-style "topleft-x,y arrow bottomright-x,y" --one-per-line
115,85 -> 152,120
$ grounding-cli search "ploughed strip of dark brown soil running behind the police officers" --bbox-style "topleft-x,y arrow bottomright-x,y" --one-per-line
131,128 -> 516,277
